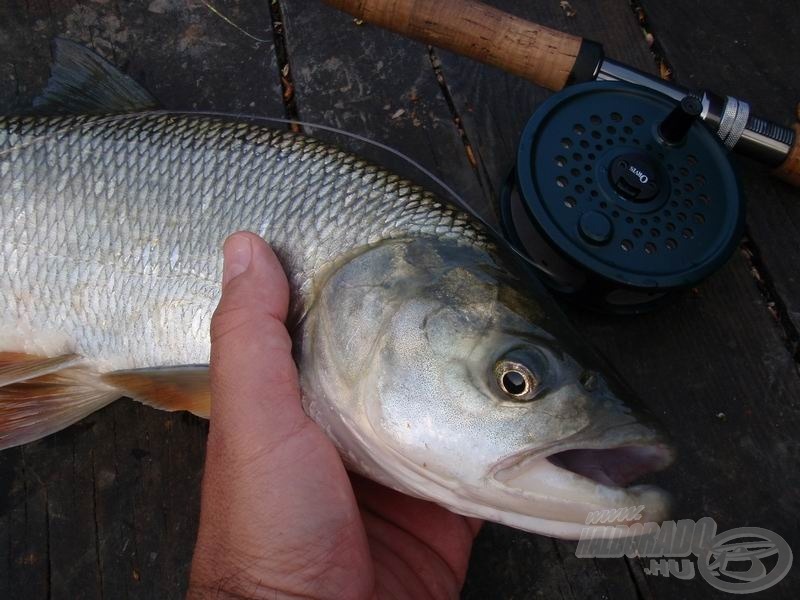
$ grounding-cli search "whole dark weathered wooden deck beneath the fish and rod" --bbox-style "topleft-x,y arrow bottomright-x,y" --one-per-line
0,0 -> 800,600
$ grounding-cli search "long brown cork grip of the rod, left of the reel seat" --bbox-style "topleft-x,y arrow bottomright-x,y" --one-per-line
324,0 -> 582,90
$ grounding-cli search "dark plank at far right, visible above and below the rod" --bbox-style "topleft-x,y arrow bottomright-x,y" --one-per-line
641,0 -> 800,338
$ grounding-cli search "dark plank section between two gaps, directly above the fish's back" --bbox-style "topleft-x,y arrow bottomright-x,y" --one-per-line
281,2 -> 488,223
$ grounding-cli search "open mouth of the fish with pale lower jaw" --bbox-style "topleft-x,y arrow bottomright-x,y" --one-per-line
492,443 -> 674,538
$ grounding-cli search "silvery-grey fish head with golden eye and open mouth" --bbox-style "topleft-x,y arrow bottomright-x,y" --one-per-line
301,238 -> 672,538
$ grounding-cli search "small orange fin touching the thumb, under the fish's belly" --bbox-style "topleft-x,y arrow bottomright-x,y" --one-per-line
101,365 -> 211,419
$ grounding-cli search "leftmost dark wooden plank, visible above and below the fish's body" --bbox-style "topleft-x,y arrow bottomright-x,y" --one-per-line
0,0 -> 283,600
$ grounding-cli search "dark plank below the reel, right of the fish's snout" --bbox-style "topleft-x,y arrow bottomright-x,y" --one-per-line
573,255 -> 800,598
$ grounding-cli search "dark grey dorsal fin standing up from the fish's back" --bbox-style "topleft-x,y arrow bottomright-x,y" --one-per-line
33,38 -> 158,114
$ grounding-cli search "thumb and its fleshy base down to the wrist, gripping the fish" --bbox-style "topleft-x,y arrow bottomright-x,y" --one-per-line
189,233 -> 369,598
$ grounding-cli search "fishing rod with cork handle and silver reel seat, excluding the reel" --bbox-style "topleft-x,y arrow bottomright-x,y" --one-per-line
323,0 -> 800,186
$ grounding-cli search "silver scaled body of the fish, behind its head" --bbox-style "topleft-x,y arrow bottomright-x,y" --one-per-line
0,113 -> 483,369
